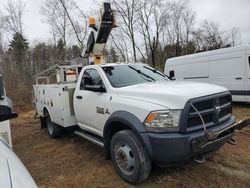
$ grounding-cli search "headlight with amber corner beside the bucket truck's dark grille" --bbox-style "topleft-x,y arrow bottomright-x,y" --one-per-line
144,110 -> 181,129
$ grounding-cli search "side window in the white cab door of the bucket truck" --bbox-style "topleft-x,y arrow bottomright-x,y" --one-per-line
80,69 -> 103,90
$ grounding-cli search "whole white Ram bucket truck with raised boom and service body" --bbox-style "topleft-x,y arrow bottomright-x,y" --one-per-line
33,3 -> 249,184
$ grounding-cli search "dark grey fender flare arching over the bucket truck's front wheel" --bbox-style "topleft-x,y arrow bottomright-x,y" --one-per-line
103,111 -> 147,159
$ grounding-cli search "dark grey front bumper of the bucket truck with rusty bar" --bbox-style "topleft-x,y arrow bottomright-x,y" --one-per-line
140,117 -> 250,166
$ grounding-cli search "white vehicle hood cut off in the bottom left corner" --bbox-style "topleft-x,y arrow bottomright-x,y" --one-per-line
0,138 -> 37,188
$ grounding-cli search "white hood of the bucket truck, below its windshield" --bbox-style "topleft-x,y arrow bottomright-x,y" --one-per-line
118,81 -> 228,109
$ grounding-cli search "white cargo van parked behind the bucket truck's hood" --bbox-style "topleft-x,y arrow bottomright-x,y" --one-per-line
164,46 -> 250,102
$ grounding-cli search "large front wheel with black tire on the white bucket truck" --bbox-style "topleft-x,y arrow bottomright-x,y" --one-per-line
110,130 -> 151,184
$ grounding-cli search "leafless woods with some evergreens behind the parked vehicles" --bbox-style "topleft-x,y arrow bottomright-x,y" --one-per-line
0,0 -> 240,104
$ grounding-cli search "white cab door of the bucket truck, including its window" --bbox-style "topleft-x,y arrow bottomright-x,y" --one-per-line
74,68 -> 108,136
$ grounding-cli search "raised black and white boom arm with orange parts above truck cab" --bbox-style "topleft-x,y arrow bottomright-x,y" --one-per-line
81,3 -> 115,65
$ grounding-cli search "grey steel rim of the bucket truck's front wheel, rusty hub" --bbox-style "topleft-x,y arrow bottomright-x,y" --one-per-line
115,142 -> 135,175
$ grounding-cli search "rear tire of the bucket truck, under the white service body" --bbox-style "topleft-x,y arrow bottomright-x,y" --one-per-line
45,113 -> 62,138
